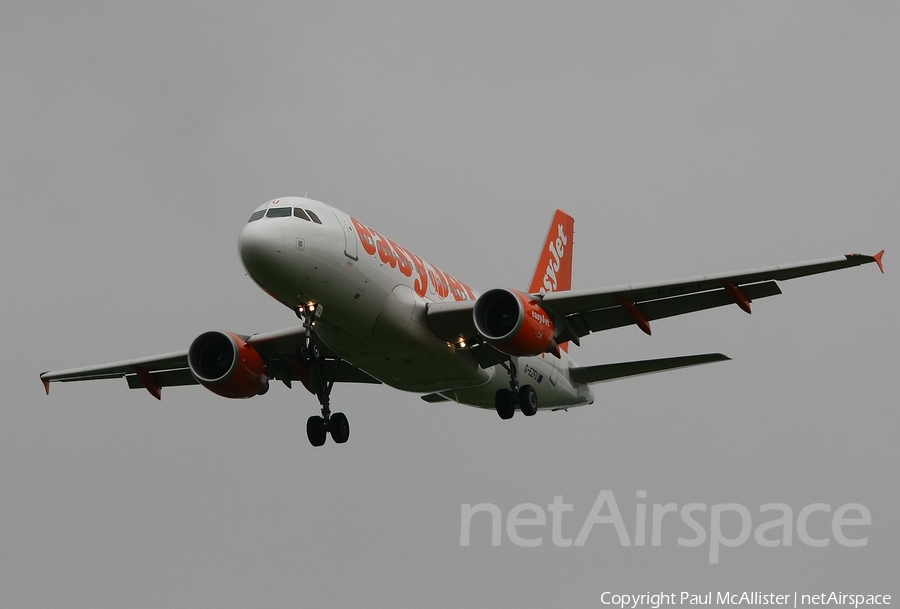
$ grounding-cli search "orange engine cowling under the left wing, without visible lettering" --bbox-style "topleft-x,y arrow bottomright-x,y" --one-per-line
188,331 -> 269,398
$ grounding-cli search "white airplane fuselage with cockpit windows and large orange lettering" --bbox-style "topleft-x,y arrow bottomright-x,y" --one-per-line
239,197 -> 593,409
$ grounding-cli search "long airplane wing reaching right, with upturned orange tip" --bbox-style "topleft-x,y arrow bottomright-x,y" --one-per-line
426,250 -> 884,350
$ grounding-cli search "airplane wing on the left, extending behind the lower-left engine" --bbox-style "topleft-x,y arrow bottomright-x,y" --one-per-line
41,326 -> 381,399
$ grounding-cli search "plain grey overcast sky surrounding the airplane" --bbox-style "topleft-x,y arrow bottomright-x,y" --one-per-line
0,0 -> 900,608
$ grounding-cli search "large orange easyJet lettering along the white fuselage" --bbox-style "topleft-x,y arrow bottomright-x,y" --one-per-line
350,217 -> 475,300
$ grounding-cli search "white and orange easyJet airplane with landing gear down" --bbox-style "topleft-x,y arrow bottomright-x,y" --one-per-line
40,197 -> 884,446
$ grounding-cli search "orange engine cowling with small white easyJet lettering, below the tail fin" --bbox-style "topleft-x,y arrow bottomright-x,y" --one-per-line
473,288 -> 558,356
